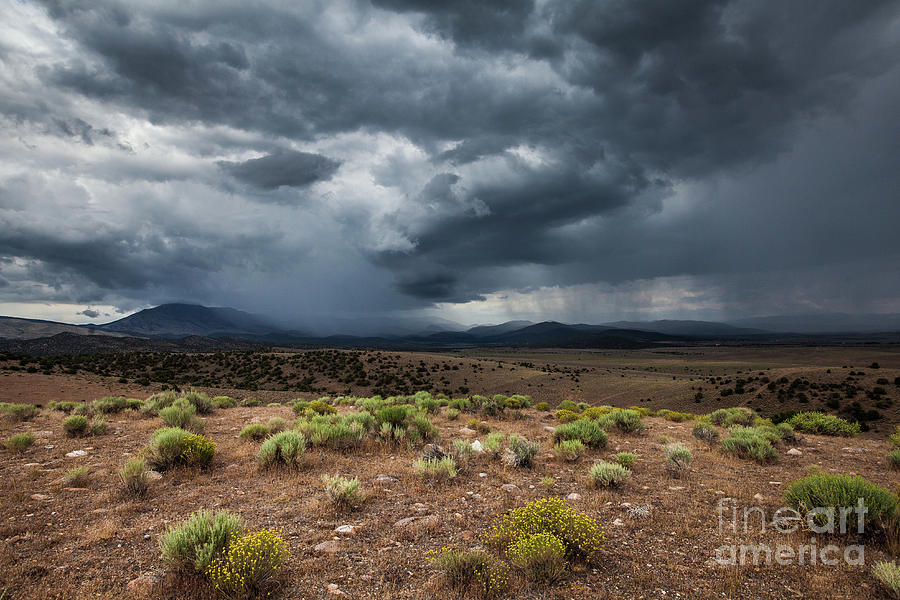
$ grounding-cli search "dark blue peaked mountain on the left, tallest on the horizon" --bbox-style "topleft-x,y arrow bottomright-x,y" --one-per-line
96,304 -> 278,337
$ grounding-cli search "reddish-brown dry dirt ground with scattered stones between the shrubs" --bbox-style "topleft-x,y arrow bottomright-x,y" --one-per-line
0,349 -> 900,600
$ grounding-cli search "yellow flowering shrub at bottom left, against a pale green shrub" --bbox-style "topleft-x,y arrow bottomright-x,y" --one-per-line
206,529 -> 287,598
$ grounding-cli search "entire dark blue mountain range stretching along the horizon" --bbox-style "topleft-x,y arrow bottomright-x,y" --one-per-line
0,304 -> 900,352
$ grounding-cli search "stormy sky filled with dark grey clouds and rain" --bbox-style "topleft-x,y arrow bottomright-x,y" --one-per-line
0,0 -> 900,323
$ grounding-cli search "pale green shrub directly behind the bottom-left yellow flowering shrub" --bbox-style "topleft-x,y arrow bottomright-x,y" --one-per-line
159,510 -> 243,573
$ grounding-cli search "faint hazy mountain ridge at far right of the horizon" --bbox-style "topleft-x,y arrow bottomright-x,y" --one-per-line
729,313 -> 900,333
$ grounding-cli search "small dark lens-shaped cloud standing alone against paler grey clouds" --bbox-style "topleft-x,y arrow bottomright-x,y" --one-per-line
219,151 -> 341,190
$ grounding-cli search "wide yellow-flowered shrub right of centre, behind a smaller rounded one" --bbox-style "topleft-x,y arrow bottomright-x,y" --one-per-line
484,497 -> 605,559
